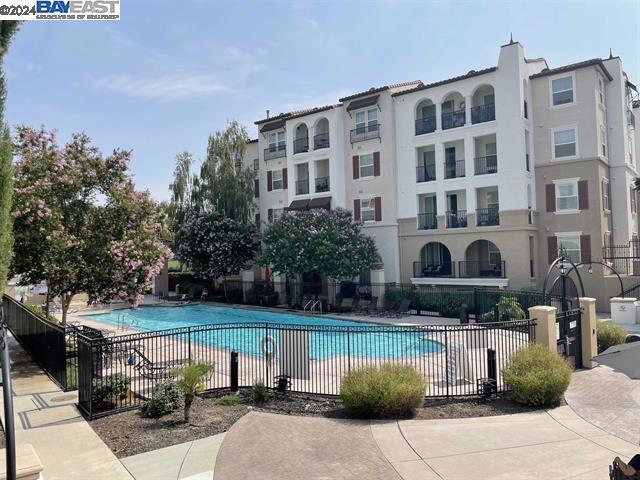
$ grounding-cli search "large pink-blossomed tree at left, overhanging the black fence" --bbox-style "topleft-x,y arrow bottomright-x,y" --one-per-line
12,126 -> 170,323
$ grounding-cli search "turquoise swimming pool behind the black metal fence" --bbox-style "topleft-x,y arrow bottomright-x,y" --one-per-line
86,305 -> 442,359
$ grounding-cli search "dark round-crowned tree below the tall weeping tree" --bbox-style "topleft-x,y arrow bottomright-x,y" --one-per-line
176,212 -> 260,280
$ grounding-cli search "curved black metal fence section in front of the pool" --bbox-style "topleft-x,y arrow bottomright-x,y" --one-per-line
78,320 -> 535,417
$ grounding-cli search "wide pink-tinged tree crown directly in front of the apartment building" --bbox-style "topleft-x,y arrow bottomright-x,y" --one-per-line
260,209 -> 380,279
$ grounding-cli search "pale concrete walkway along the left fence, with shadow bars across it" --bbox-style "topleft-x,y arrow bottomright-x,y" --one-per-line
0,337 -> 131,480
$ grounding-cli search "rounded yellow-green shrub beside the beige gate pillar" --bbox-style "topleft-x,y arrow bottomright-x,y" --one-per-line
502,343 -> 573,407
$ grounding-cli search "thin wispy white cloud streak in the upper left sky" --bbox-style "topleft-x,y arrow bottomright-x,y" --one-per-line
95,74 -> 231,101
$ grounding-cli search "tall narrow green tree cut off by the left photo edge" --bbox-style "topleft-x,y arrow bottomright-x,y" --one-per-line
0,20 -> 20,292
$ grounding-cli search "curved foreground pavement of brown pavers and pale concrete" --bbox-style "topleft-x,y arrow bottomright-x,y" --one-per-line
214,406 -> 638,480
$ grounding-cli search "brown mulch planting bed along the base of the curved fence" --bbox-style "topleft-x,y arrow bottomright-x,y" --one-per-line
89,389 -> 534,458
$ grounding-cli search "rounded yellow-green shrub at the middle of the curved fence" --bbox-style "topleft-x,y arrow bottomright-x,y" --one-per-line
340,363 -> 427,417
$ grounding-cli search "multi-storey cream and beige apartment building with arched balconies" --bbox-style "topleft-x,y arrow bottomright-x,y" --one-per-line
244,41 -> 640,304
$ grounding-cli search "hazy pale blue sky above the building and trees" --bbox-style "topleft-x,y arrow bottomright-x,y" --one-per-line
4,0 -> 640,200
